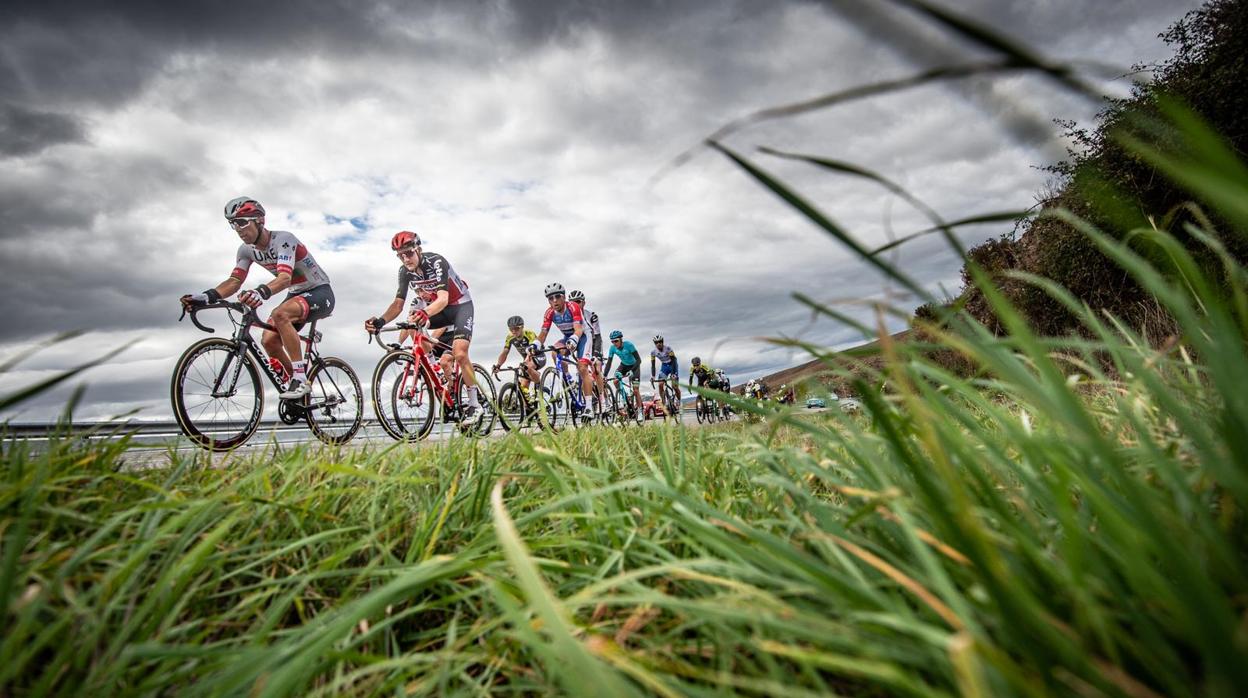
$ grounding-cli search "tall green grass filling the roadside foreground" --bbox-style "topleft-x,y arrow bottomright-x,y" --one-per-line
7,4 -> 1248,697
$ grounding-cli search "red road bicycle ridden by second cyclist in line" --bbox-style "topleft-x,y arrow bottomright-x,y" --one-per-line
368,322 -> 498,441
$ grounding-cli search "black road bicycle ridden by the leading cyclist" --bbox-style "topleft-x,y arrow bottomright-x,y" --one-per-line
170,301 -> 364,451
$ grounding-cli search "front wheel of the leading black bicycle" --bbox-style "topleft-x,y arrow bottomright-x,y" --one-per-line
170,337 -> 265,451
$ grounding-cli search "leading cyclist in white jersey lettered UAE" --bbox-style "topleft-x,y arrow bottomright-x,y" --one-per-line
181,196 -> 333,400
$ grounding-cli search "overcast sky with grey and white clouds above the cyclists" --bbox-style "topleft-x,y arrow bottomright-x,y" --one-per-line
0,0 -> 1197,421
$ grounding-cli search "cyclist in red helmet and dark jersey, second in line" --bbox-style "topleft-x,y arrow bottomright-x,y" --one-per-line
364,230 -> 480,422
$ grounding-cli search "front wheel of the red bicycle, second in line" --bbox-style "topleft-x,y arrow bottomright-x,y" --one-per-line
372,351 -> 436,441
